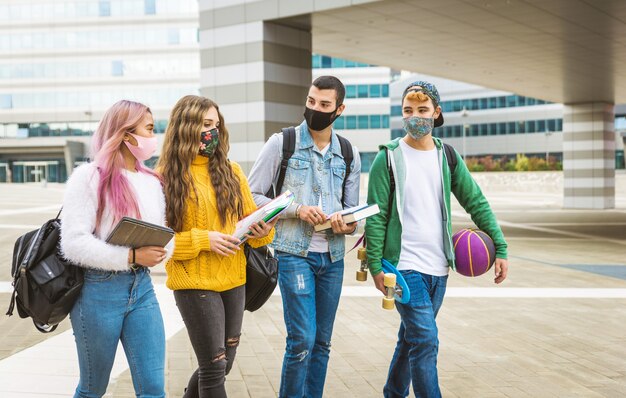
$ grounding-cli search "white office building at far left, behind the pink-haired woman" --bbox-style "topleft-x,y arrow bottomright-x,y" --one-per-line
0,0 -> 200,182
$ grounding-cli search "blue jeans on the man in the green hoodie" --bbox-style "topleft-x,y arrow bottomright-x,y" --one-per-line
383,271 -> 448,398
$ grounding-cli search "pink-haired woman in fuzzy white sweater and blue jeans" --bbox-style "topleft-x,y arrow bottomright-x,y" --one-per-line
61,101 -> 172,397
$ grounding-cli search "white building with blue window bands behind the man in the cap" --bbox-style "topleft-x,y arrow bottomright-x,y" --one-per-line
390,74 -> 626,169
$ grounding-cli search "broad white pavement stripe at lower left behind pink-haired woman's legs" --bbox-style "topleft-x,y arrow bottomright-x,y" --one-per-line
0,282 -> 184,398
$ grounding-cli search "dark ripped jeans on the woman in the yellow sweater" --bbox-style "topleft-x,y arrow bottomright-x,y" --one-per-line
174,286 -> 246,398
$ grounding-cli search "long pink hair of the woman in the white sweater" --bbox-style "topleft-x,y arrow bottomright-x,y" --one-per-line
91,100 -> 162,230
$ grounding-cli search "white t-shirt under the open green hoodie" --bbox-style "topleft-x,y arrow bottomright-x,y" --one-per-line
398,140 -> 448,276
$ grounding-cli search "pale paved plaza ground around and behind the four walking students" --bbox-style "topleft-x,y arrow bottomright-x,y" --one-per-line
0,172 -> 626,398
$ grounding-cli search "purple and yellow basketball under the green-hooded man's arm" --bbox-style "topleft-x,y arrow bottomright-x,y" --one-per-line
452,229 -> 496,276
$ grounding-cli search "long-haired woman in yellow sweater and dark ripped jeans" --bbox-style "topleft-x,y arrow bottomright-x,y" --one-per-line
158,95 -> 275,397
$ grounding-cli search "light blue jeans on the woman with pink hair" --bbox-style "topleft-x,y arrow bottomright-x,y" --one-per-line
70,267 -> 165,398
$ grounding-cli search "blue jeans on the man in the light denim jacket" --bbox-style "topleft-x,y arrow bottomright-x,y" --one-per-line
276,251 -> 343,398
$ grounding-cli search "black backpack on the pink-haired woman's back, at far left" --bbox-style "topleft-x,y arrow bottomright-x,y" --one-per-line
7,211 -> 83,333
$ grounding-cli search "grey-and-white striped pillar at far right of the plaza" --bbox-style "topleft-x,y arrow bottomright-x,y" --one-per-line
563,102 -> 615,209
